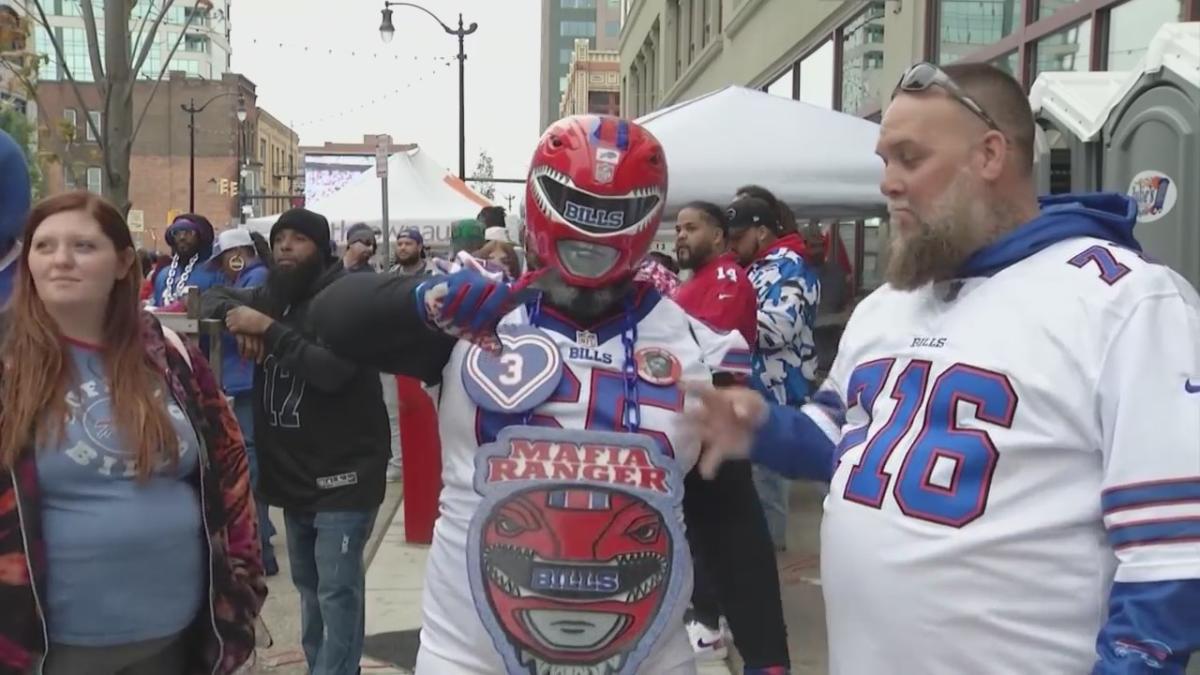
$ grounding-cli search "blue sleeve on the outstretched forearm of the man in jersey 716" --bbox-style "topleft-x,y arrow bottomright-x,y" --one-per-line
750,404 -> 834,483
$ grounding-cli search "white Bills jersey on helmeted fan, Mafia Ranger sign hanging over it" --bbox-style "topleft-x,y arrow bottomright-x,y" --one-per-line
416,288 -> 750,675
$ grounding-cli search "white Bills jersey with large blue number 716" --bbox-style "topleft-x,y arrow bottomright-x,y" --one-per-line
806,238 -> 1200,675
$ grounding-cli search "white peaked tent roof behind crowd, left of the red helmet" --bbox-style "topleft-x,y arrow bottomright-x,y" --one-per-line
246,148 -> 492,245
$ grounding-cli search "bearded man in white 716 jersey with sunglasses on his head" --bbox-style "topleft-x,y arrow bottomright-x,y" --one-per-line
692,64 -> 1200,675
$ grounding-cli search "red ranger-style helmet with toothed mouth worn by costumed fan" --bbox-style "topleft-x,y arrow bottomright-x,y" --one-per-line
526,115 -> 667,288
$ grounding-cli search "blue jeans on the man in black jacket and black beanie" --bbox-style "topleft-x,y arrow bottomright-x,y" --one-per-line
283,509 -> 378,675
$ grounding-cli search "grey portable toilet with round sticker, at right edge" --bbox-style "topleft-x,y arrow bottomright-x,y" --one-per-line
1102,22 -> 1200,288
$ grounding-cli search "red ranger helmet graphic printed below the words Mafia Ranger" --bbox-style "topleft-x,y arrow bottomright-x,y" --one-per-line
482,488 -> 671,674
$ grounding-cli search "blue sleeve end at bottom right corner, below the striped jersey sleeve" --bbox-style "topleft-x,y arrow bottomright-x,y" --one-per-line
1092,579 -> 1200,675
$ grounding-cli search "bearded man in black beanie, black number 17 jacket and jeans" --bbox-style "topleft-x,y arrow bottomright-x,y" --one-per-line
203,209 -> 389,675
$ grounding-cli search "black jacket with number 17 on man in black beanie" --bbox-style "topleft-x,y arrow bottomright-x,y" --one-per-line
202,264 -> 391,510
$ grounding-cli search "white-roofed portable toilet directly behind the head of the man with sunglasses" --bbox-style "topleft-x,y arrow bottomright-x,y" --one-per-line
1030,72 -> 1132,195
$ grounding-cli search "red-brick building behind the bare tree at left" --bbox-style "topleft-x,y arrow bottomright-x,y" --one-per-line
37,71 -> 259,249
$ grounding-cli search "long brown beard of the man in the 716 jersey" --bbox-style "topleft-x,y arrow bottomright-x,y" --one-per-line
883,171 -> 1004,291
